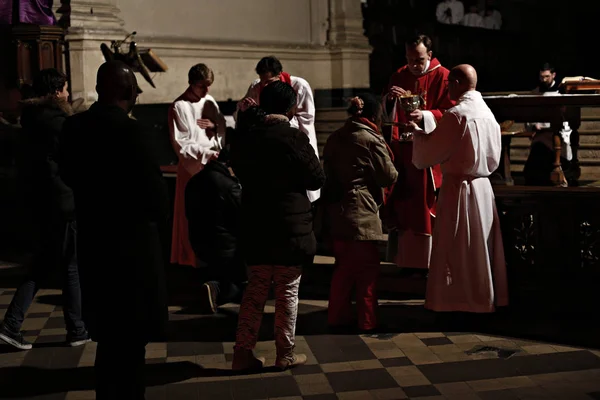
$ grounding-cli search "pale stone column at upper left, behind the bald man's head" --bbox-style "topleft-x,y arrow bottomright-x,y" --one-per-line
63,0 -> 127,106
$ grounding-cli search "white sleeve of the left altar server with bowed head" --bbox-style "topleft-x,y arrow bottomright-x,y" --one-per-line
173,102 -> 219,165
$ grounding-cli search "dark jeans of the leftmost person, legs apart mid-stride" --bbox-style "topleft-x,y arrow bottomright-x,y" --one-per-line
4,221 -> 86,338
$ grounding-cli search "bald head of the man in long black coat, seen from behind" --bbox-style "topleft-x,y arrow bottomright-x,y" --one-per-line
96,61 -> 138,112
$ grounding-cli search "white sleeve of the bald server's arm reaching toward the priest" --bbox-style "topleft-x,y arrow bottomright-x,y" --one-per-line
412,112 -> 466,169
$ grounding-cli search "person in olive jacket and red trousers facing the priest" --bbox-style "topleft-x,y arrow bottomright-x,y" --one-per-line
323,94 -> 398,332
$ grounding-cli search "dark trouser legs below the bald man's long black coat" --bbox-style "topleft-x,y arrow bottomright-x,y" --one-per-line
94,337 -> 146,400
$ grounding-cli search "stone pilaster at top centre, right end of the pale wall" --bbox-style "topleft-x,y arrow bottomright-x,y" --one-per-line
327,0 -> 371,89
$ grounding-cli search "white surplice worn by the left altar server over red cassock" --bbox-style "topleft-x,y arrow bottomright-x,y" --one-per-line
171,94 -> 223,176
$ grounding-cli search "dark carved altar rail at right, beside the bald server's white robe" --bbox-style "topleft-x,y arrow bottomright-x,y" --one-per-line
494,185 -> 600,312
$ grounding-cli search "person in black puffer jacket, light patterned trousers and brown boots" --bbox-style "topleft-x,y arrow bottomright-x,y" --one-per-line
231,81 -> 325,370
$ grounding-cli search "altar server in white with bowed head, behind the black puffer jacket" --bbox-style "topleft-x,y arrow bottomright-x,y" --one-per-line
238,56 -> 321,202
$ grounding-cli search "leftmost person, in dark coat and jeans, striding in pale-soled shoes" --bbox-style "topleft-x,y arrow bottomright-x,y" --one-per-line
0,68 -> 89,350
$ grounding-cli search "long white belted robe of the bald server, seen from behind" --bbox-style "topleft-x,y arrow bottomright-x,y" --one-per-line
413,91 -> 508,313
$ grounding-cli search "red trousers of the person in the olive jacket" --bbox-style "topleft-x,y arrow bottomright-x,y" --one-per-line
328,240 -> 380,330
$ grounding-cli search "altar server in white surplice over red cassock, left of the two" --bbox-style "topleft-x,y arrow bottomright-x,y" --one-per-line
169,64 -> 226,267
